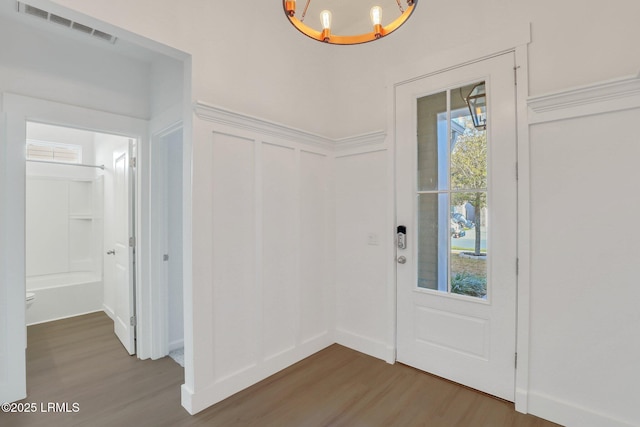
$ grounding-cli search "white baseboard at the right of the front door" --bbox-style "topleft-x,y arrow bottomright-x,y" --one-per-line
528,392 -> 640,427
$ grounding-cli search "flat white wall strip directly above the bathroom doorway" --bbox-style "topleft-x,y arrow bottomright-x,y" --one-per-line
0,16 -> 150,118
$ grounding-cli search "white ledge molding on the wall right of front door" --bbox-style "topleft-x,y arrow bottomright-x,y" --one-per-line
527,74 -> 640,124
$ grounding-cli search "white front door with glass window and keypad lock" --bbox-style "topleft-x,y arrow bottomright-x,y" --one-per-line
395,53 -> 517,401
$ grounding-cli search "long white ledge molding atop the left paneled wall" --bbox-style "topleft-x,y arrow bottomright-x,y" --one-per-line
193,101 -> 335,150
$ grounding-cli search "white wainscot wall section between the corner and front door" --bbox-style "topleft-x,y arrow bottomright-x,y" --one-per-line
334,148 -> 394,361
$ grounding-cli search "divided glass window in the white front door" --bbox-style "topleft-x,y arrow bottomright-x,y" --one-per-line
416,82 -> 488,298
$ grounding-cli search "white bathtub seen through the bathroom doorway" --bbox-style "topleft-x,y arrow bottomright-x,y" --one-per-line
27,272 -> 104,325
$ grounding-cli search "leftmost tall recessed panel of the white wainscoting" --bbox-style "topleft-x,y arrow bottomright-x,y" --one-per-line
211,132 -> 259,379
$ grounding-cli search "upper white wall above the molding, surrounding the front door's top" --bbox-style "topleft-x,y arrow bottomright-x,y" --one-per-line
325,0 -> 640,137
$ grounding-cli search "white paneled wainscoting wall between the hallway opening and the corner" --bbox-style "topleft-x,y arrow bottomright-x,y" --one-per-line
182,104 -> 334,413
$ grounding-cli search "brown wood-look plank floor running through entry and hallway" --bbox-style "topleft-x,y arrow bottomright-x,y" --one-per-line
0,313 -> 557,427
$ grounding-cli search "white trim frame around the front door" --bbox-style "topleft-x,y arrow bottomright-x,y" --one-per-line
386,23 -> 531,413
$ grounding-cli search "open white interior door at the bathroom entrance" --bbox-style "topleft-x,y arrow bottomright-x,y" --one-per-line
113,146 -> 136,354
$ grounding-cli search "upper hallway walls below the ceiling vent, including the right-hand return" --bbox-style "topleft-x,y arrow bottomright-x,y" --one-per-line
0,5 -> 184,124
